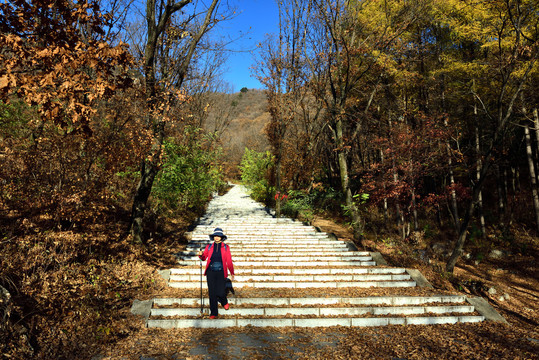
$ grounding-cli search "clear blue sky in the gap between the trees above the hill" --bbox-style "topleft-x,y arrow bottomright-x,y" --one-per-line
217,0 -> 279,92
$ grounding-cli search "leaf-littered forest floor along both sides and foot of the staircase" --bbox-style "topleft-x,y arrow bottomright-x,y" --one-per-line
0,207 -> 539,360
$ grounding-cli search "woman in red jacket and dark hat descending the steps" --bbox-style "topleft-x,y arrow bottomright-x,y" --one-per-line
197,228 -> 234,319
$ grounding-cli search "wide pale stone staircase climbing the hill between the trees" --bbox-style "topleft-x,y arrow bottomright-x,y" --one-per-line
132,186 -> 503,328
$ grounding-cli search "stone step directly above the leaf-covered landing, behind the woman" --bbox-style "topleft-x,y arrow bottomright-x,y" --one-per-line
168,275 -> 417,289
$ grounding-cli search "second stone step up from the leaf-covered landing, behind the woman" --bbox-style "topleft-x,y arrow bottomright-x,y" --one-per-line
170,267 -> 406,276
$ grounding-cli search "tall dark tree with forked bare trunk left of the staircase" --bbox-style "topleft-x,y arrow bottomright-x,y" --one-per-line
130,0 -> 224,242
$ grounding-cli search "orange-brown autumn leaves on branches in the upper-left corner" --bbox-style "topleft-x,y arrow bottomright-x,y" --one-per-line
0,1 -> 131,132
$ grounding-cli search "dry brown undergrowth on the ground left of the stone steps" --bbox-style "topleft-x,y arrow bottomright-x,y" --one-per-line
0,205 -> 193,359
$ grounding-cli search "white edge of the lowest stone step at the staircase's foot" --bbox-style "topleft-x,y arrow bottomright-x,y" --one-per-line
146,316 -> 485,329
